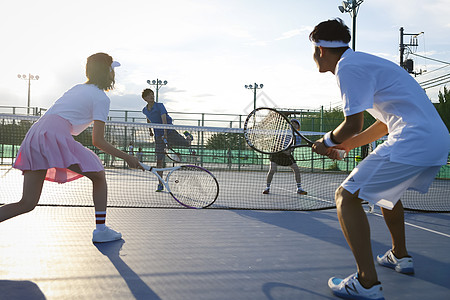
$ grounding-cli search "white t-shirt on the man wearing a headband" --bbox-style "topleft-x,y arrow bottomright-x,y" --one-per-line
335,49 -> 450,166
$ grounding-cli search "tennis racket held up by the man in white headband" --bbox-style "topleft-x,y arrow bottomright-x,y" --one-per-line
244,107 -> 345,158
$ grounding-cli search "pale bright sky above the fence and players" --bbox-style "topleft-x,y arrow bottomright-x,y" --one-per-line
0,0 -> 450,114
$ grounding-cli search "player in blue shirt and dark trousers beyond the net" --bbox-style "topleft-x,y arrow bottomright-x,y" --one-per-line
142,89 -> 192,192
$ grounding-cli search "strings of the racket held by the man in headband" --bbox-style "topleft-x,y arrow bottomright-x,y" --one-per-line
246,110 -> 294,153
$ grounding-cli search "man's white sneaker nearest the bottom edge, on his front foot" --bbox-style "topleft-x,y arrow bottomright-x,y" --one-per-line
328,273 -> 384,300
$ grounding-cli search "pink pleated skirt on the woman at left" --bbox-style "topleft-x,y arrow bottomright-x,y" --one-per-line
13,115 -> 104,183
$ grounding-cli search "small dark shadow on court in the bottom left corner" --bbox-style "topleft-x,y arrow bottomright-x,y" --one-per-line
0,280 -> 45,300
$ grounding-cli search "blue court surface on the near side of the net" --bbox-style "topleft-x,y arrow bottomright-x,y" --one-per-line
0,206 -> 450,300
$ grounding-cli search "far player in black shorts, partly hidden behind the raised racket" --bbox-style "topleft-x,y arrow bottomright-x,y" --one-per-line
263,119 -> 307,195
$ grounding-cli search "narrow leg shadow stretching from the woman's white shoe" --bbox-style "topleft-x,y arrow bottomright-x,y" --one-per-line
94,239 -> 161,300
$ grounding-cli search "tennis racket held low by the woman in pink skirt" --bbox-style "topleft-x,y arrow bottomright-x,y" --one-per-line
140,163 -> 219,208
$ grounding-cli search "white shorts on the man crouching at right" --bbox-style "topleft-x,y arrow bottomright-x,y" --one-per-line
341,153 -> 441,209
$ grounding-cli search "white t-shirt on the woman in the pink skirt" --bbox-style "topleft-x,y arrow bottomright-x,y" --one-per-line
46,84 -> 111,135
